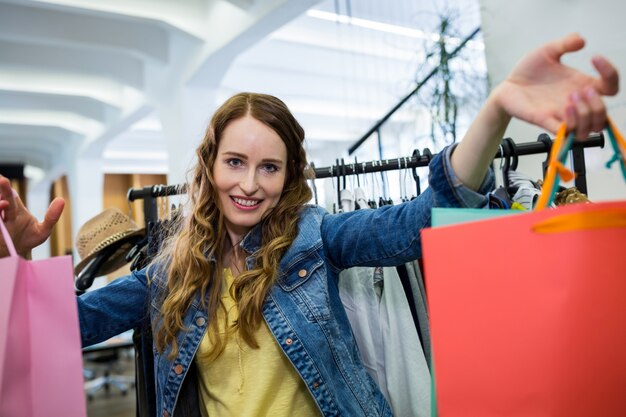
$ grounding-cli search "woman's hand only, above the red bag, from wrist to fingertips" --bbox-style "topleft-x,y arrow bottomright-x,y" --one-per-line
492,34 -> 619,139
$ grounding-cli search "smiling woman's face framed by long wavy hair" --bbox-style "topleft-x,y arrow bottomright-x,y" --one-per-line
213,116 -> 287,244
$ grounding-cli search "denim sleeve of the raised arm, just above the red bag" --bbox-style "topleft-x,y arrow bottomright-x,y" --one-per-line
321,146 -> 494,270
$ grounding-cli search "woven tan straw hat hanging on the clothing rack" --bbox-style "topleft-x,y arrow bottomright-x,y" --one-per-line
74,208 -> 145,276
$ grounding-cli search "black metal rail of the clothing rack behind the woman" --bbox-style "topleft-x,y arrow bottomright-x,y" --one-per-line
127,133 -> 604,228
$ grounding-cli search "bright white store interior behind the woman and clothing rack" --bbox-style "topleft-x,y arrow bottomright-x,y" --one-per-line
0,0 -> 626,262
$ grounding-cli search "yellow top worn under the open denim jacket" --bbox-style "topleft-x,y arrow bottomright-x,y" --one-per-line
195,269 -> 320,417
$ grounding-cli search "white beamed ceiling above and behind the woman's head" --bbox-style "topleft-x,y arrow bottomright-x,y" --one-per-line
0,0 -> 484,185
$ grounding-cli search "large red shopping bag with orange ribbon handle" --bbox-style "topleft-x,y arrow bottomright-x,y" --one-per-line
423,202 -> 626,417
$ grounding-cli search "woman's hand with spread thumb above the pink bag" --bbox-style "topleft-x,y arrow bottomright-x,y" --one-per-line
0,175 -> 65,258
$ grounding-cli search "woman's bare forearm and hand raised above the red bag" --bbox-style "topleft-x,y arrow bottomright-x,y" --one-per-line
451,34 -> 619,189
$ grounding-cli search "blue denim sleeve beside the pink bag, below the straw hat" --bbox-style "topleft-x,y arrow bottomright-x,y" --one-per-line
77,269 -> 148,346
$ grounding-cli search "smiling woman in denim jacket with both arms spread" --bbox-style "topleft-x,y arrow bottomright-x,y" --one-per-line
0,35 -> 618,416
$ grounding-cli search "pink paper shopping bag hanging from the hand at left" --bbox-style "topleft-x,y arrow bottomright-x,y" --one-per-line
0,219 -> 86,417
